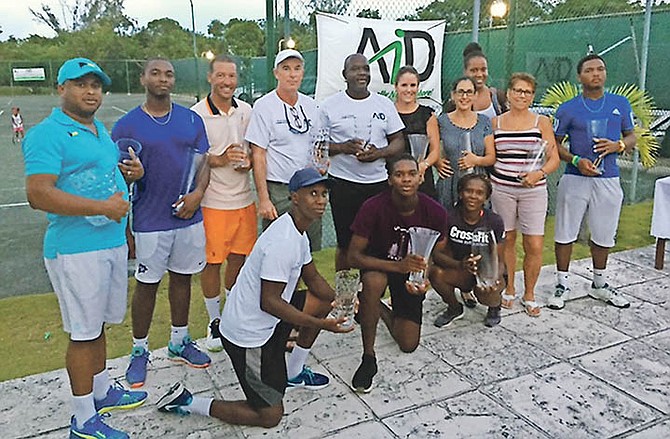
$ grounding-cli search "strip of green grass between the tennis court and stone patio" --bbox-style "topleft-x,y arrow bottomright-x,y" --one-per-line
0,201 -> 654,381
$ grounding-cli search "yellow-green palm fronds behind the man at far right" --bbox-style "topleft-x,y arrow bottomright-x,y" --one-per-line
540,81 -> 661,168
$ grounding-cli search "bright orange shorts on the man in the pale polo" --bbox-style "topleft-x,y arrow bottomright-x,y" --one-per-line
202,203 -> 258,264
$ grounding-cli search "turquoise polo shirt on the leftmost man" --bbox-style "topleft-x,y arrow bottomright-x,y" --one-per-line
22,108 -> 128,259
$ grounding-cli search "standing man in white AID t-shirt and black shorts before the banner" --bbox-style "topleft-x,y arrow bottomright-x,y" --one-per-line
321,53 -> 405,270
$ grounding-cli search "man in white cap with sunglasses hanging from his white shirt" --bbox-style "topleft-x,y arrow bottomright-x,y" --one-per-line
245,49 -> 321,251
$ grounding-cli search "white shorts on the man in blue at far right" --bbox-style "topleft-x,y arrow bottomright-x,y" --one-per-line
554,174 -> 623,248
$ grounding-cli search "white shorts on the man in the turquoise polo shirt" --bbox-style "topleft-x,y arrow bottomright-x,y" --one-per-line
44,244 -> 128,341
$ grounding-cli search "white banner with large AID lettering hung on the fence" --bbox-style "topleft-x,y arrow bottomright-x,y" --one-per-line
316,13 -> 446,106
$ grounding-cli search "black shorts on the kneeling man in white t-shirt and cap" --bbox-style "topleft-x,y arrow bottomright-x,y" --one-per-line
221,291 -> 305,409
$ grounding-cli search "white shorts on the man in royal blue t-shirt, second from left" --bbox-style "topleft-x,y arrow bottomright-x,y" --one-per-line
135,221 -> 205,284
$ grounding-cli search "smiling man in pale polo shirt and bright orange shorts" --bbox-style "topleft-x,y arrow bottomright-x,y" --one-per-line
191,55 -> 258,352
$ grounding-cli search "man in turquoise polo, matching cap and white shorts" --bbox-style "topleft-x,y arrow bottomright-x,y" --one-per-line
23,58 -> 147,439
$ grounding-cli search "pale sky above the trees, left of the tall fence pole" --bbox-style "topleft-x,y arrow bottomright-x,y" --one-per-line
0,0 -> 268,41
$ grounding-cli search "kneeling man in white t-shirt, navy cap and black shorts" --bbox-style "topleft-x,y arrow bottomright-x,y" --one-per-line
157,168 -> 352,428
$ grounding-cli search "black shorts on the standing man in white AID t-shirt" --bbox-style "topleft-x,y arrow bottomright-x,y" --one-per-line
330,177 -> 388,249
